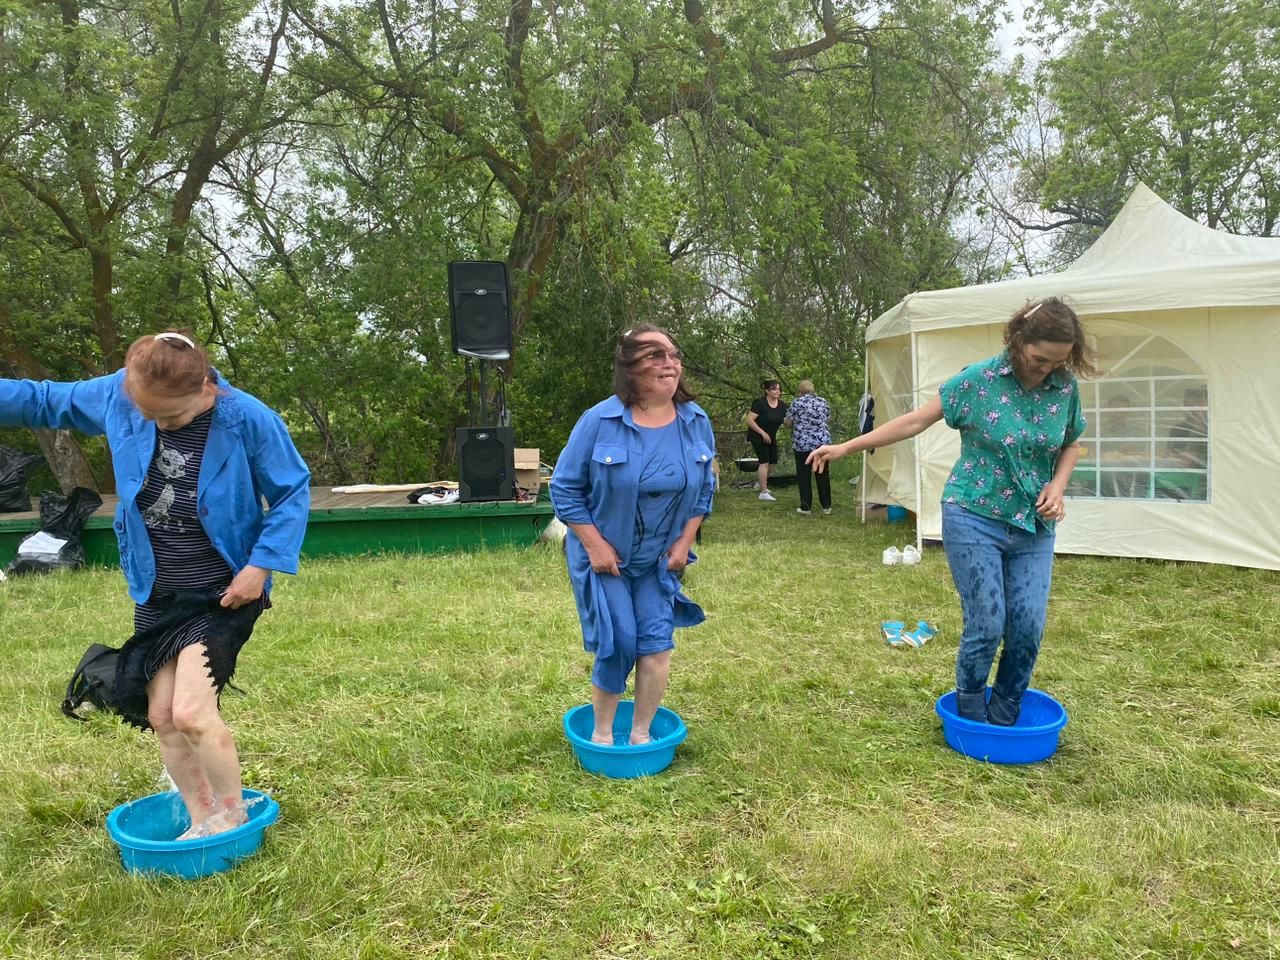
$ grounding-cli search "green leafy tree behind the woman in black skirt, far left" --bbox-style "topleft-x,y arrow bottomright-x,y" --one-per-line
0,0 -> 304,480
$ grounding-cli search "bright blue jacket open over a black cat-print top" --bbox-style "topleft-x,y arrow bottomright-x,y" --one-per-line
0,370 -> 311,603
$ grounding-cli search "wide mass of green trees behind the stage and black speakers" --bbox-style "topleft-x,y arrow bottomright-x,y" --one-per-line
0,0 -> 1006,483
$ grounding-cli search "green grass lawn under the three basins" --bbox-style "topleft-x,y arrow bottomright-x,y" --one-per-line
0,484 -> 1280,960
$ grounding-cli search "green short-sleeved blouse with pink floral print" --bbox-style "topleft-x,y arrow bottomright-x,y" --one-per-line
938,351 -> 1085,532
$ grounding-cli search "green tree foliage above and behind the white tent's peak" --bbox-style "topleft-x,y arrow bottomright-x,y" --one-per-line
1027,0 -> 1280,236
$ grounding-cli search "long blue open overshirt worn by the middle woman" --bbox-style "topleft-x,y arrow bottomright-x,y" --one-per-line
550,396 -> 716,657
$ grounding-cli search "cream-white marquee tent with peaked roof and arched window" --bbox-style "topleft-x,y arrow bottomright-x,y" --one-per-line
861,184 -> 1280,570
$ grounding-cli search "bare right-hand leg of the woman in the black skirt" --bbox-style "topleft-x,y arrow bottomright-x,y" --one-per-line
170,644 -> 247,835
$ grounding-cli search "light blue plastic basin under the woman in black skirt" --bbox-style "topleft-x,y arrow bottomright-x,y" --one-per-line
106,790 -> 280,879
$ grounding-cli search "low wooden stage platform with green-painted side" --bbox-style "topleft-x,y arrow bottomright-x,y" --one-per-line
0,486 -> 554,568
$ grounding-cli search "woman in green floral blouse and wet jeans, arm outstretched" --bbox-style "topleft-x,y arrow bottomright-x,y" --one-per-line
809,298 -> 1097,726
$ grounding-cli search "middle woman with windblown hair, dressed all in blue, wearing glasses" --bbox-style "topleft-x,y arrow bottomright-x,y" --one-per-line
552,324 -> 716,745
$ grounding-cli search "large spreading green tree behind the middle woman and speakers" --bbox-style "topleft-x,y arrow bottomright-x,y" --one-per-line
280,0 -> 1002,463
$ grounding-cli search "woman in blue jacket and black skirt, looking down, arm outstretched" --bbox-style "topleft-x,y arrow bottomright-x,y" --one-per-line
0,330 -> 311,838
